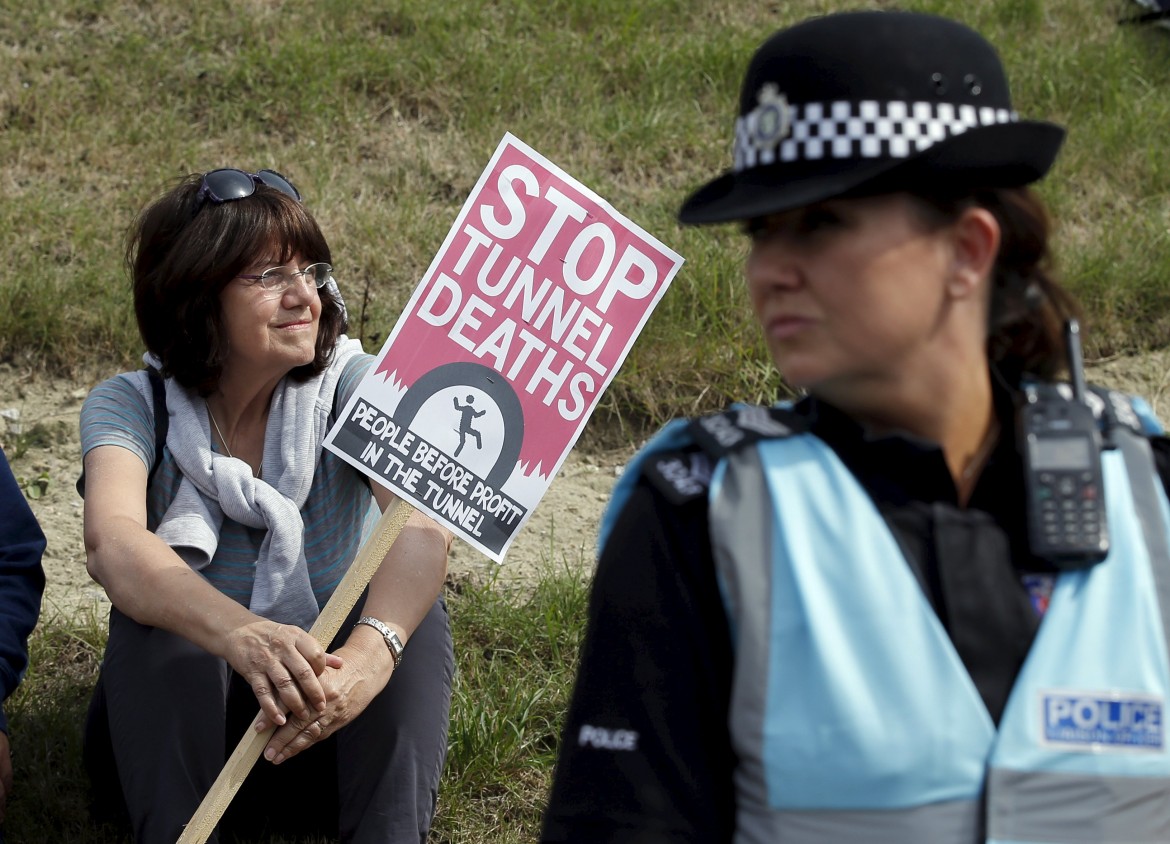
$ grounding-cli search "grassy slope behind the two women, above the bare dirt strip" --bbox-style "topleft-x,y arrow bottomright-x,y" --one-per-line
0,0 -> 1170,425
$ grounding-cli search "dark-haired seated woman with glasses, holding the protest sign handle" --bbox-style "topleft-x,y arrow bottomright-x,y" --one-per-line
80,169 -> 454,844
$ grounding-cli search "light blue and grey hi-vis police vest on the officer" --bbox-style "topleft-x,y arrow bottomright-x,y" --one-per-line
603,409 -> 1170,844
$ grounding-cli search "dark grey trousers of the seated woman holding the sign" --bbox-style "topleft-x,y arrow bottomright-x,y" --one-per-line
84,599 -> 454,844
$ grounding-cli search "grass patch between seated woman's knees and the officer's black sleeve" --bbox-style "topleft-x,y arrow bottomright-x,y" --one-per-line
432,565 -> 587,844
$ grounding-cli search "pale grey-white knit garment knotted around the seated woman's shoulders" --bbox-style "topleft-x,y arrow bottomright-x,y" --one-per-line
144,335 -> 362,630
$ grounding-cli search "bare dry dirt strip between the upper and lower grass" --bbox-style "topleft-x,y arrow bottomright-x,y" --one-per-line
0,350 -> 1170,618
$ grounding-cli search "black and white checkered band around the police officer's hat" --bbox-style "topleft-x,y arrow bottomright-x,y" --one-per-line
734,101 -> 1019,172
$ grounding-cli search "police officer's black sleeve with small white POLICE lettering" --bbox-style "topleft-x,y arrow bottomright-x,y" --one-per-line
541,470 -> 735,844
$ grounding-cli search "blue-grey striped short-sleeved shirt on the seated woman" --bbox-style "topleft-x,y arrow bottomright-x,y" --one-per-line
81,355 -> 374,606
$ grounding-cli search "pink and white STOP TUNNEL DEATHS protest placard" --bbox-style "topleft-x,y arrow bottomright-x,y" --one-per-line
325,135 -> 682,562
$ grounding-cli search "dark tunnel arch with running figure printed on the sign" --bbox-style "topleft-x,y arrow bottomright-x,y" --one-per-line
394,363 -> 524,489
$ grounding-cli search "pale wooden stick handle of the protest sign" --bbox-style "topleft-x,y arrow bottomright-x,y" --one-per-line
178,499 -> 414,844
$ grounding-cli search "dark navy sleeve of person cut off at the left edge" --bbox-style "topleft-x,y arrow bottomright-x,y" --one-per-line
0,450 -> 44,733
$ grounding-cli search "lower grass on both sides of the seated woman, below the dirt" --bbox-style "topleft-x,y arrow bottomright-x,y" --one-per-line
5,564 -> 587,844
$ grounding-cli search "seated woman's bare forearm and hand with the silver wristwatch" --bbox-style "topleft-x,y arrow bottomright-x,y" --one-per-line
256,483 -> 454,764
